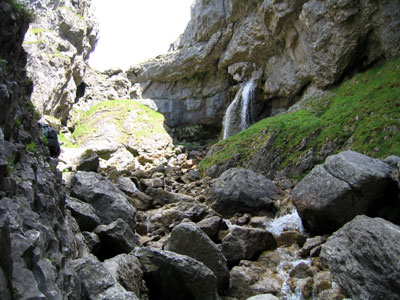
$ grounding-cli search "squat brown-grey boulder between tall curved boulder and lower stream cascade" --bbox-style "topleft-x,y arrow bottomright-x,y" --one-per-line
222,226 -> 277,263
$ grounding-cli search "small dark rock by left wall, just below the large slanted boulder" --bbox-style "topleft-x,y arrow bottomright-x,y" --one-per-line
66,197 -> 101,231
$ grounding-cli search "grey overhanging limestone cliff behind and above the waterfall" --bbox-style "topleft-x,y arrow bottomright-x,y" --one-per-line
128,0 -> 400,137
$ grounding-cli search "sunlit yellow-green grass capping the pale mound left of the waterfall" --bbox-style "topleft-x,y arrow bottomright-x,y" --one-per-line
65,100 -> 166,147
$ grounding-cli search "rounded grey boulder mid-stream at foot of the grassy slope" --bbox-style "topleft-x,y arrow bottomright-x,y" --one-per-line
209,169 -> 279,218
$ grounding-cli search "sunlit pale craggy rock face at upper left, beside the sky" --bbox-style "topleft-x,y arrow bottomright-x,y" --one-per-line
24,0 -> 98,121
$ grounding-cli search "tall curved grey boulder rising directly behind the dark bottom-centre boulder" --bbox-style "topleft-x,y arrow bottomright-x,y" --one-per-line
165,223 -> 229,292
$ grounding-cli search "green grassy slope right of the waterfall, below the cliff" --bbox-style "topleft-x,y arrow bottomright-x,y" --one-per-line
200,59 -> 400,176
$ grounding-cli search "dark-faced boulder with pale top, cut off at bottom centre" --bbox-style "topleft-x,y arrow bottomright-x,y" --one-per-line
134,247 -> 218,300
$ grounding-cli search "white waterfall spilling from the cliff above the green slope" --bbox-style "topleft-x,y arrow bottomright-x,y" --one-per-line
223,79 -> 256,139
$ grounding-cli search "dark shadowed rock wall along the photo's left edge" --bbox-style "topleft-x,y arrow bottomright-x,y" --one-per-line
0,1 -> 87,300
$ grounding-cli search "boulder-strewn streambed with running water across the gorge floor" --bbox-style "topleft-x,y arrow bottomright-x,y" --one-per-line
54,131 -> 400,300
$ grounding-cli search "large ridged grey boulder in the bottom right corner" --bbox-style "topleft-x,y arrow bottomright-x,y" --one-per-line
320,216 -> 400,300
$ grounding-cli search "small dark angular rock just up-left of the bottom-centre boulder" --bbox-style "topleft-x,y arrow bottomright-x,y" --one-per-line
95,219 -> 141,260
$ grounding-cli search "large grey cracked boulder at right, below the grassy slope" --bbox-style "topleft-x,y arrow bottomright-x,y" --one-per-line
293,151 -> 394,233
